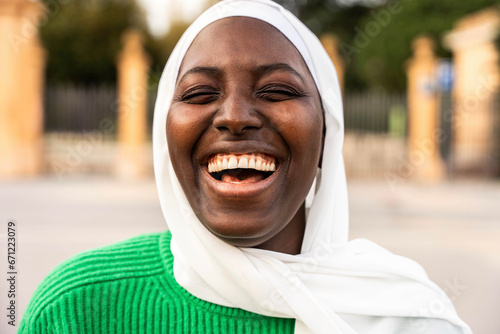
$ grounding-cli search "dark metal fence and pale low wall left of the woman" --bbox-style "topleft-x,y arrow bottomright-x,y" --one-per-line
44,86 -> 156,176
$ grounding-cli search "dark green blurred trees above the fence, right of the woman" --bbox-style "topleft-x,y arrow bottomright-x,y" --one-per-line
278,0 -> 498,91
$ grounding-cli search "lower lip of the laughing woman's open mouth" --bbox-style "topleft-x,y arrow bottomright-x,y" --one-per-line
202,166 -> 281,199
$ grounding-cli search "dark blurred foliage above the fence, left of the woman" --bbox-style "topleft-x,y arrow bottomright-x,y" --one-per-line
40,0 -> 149,84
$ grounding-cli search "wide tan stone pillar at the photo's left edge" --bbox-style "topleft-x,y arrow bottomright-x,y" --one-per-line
0,0 -> 47,178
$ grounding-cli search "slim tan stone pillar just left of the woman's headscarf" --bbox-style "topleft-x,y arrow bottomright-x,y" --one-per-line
115,30 -> 149,178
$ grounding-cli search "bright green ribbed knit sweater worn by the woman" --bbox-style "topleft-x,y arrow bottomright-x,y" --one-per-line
18,232 -> 295,334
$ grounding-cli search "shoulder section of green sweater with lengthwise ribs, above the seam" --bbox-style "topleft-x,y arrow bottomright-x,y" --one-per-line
20,231 -> 171,328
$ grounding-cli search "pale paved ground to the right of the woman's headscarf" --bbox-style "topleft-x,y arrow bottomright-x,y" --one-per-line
349,181 -> 500,334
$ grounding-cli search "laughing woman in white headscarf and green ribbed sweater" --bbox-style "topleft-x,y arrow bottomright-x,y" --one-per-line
20,0 -> 471,334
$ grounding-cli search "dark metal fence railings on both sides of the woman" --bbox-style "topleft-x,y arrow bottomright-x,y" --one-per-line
45,85 -> 407,136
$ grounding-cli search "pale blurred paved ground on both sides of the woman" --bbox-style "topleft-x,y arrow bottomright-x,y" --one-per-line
0,176 -> 500,334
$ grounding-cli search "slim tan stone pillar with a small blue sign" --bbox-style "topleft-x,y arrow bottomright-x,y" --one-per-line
406,37 -> 444,181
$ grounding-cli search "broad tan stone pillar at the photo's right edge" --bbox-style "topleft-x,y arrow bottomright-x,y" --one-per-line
443,7 -> 500,172
